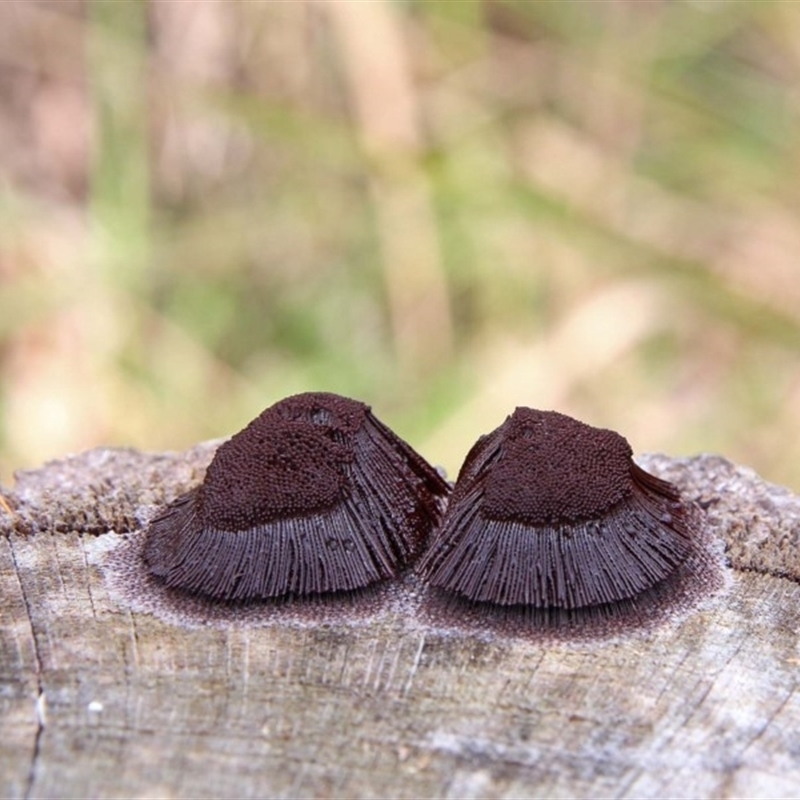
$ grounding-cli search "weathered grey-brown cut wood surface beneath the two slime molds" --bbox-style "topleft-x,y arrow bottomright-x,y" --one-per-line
0,444 -> 800,798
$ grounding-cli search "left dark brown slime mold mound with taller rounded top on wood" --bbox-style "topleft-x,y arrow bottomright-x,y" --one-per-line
143,393 -> 449,600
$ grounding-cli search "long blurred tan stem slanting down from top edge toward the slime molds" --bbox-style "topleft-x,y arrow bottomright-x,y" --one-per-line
322,0 -> 453,376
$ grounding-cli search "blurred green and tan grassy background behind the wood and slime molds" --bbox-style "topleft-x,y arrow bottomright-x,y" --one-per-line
0,0 -> 800,489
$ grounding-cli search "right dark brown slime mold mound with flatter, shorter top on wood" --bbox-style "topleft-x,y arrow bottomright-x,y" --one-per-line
419,408 -> 699,617
